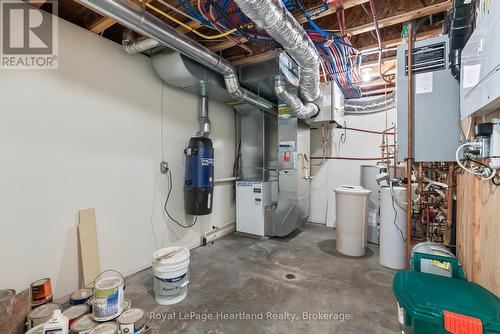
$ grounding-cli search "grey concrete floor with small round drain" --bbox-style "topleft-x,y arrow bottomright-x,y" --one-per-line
125,224 -> 400,334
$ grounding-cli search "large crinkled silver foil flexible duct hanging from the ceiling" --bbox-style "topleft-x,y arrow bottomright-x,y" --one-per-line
235,0 -> 321,118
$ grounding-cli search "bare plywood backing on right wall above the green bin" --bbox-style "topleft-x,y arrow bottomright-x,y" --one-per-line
457,110 -> 500,296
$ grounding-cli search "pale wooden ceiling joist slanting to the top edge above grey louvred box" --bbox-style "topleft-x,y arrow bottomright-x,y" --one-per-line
347,0 -> 452,36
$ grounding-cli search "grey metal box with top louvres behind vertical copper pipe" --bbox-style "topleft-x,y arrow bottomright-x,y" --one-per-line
396,35 -> 460,162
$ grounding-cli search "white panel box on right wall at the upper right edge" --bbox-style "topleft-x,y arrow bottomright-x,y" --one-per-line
460,0 -> 500,118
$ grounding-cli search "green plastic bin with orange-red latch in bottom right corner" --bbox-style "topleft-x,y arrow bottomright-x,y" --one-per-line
393,271 -> 500,334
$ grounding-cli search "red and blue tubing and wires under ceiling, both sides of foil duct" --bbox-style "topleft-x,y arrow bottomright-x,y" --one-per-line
148,0 -> 361,98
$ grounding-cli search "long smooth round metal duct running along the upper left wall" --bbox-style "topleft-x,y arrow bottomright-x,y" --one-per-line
77,0 -> 275,110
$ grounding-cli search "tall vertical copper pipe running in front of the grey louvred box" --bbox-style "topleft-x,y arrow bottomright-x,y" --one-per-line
406,24 -> 413,269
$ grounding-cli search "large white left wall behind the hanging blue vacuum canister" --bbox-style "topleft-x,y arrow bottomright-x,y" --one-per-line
0,14 -> 235,298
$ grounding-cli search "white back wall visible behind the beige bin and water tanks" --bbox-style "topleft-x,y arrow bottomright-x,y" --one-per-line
309,110 -> 396,224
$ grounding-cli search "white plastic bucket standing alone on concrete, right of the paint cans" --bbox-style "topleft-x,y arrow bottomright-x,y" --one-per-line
153,247 -> 190,305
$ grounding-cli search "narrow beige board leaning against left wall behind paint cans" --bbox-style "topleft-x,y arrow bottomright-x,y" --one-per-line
78,209 -> 101,286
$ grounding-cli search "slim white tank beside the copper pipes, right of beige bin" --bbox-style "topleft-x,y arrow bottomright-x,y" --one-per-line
378,187 -> 406,270
